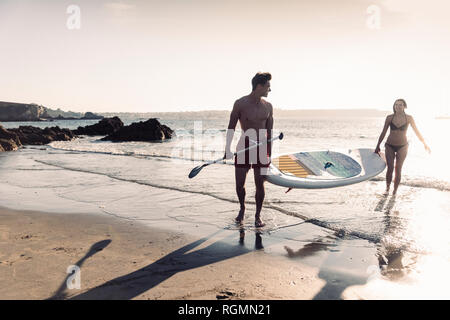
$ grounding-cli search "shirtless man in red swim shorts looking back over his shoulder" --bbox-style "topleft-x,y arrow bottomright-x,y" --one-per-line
224,73 -> 273,227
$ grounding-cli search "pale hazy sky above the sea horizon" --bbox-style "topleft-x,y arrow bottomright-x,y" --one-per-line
0,0 -> 450,114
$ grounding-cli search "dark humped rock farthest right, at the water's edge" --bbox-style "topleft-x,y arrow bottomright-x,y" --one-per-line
102,118 -> 174,141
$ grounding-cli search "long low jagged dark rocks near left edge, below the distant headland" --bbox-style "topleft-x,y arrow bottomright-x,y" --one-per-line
9,126 -> 75,145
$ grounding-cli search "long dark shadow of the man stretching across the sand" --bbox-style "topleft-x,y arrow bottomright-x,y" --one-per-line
55,230 -> 251,300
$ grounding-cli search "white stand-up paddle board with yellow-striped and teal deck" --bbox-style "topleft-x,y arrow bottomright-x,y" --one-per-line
267,149 -> 386,189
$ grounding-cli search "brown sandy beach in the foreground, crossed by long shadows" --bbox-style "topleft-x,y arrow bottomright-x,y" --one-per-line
0,209 -> 330,299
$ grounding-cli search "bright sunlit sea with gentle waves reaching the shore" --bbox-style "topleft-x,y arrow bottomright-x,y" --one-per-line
0,113 -> 450,298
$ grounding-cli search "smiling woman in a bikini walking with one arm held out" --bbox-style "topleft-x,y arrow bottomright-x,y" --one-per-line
375,99 -> 431,195
